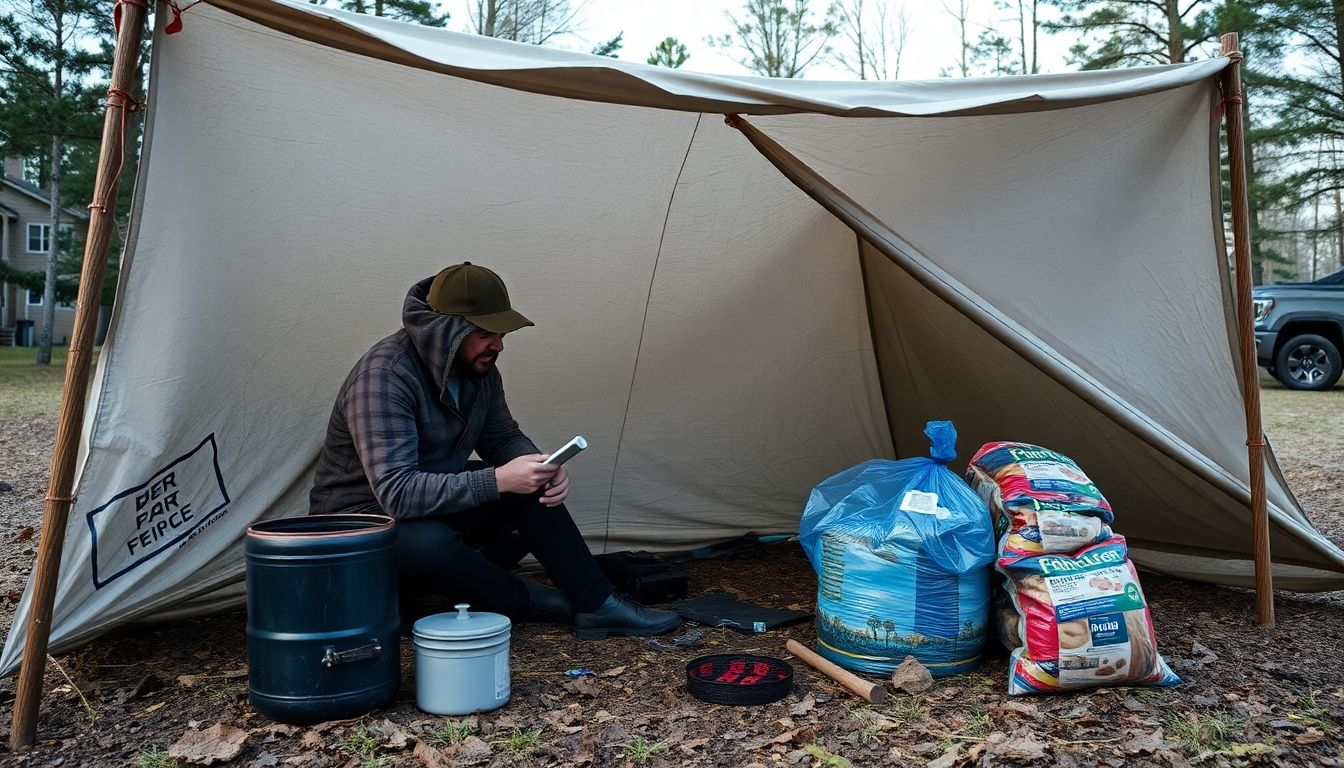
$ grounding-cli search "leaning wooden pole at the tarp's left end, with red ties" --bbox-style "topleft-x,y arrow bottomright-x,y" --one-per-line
9,0 -> 146,751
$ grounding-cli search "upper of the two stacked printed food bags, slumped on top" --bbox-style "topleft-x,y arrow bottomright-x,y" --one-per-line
966,443 -> 1114,554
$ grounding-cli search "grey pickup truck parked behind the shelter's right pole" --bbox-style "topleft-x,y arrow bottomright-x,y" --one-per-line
1253,269 -> 1344,390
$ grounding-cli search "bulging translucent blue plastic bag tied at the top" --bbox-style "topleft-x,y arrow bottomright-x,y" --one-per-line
800,421 -> 995,677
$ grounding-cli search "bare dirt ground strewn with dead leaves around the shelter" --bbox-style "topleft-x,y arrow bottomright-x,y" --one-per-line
0,381 -> 1344,768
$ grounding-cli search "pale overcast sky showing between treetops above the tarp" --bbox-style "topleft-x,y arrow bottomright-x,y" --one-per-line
444,0 -> 1070,79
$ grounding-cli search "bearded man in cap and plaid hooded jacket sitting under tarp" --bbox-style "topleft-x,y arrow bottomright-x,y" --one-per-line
309,262 -> 680,638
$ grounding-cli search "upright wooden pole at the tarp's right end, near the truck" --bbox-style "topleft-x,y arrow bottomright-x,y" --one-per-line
1222,32 -> 1274,627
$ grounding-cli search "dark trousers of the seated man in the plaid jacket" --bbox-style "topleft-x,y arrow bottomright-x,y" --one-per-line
396,494 -> 612,620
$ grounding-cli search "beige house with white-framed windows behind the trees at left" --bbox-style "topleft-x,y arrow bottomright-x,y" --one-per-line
0,157 -> 89,346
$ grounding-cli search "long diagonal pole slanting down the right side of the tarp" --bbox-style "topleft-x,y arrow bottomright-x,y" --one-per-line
731,110 -> 1344,573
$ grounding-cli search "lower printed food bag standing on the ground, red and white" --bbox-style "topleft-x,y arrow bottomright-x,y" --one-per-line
996,534 -> 1180,695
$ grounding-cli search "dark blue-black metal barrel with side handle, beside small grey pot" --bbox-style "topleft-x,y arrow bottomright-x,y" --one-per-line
243,515 -> 401,724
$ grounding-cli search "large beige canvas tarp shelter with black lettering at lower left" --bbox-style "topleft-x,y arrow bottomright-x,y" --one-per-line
0,0 -> 1344,670
